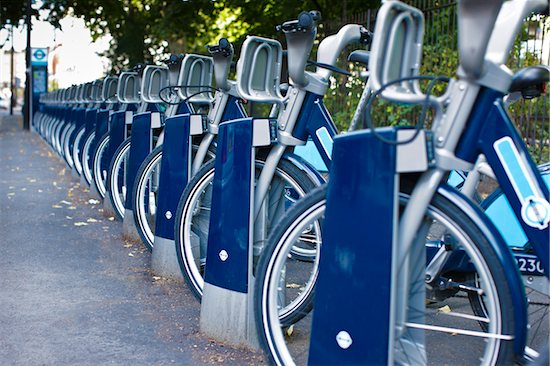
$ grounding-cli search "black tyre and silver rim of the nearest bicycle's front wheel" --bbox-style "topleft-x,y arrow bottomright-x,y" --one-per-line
254,186 -> 515,365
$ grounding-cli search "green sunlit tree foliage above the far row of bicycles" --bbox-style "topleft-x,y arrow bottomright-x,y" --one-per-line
38,0 -> 378,70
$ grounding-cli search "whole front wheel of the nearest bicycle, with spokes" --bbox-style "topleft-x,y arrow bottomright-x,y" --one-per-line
254,187 -> 515,365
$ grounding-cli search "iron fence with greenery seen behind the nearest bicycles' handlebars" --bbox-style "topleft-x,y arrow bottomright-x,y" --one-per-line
320,0 -> 550,163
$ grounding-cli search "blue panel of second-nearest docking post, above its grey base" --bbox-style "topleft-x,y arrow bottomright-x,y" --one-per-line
204,118 -> 254,293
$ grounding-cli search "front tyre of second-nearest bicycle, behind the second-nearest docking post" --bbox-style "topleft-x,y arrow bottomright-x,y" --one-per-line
174,159 -> 316,301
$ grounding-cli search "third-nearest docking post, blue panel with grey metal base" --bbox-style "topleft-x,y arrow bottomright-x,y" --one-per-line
151,113 -> 202,279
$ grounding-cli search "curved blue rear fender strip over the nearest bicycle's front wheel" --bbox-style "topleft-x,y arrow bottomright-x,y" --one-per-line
438,184 -> 527,359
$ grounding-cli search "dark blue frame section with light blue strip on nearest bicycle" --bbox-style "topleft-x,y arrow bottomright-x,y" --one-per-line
456,88 -> 550,276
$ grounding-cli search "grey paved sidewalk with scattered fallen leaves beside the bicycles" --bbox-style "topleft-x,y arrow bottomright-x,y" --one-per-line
0,112 -> 264,366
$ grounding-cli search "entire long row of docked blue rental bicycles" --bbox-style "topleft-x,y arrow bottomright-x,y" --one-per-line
33,0 -> 550,365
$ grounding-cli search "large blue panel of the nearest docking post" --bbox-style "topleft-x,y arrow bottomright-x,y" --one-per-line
309,128 -> 398,365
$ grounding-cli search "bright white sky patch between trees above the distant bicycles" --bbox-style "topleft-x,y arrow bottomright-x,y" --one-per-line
0,8 -> 110,87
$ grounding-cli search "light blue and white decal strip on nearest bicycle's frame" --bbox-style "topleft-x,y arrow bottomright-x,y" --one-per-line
493,136 -> 550,230
